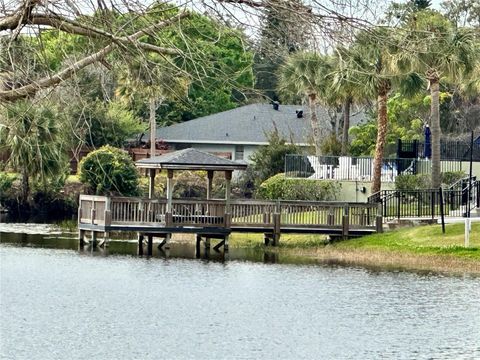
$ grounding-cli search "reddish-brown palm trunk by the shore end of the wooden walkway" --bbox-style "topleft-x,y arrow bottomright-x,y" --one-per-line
372,86 -> 388,194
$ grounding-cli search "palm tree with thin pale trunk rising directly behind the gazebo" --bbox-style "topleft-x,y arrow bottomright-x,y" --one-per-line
116,59 -> 189,157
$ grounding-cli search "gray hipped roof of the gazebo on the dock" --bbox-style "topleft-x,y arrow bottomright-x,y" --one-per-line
135,148 -> 247,171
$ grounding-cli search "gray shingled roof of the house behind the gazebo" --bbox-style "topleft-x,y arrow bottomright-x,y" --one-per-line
157,104 -> 363,144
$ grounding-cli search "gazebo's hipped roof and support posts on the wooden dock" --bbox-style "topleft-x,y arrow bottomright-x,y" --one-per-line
135,148 -> 247,253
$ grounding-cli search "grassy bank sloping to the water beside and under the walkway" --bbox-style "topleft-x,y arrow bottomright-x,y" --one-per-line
230,222 -> 480,274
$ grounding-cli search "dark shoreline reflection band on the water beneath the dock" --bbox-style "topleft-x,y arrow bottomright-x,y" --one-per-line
0,221 -> 478,277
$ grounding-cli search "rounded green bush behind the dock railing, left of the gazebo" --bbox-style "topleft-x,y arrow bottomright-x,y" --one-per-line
78,145 -> 139,196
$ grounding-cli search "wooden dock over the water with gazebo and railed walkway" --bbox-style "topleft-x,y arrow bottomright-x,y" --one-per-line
78,149 -> 382,255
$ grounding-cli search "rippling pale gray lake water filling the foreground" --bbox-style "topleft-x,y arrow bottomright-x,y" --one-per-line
0,224 -> 480,359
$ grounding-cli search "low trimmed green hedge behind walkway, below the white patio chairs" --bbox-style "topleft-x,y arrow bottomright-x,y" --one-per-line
258,174 -> 340,201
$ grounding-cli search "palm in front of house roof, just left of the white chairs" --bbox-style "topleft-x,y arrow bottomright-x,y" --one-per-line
278,52 -> 333,156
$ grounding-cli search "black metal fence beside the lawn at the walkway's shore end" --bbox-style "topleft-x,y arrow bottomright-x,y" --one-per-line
368,180 -> 480,221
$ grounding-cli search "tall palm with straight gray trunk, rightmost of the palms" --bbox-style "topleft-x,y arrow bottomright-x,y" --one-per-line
399,10 -> 479,188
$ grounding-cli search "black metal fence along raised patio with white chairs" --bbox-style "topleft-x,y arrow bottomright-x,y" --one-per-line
285,155 -> 462,182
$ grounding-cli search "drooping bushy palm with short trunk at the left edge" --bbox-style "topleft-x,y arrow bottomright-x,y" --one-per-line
0,100 -> 66,204
